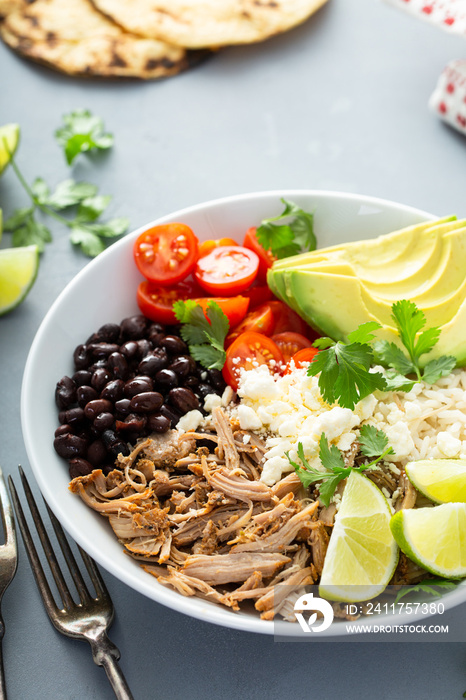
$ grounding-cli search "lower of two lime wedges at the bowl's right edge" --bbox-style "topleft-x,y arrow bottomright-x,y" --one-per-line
390,503 -> 466,578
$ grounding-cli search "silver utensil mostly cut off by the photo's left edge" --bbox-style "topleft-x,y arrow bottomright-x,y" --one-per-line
0,468 -> 18,700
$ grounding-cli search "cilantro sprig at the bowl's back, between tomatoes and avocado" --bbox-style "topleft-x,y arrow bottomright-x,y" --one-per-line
256,198 -> 317,260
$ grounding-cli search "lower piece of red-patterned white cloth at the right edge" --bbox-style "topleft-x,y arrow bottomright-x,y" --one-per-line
429,59 -> 466,133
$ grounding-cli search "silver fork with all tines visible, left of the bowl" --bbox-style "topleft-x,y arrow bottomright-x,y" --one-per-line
9,467 -> 133,700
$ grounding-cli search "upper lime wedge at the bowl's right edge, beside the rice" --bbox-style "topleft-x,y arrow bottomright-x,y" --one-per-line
405,459 -> 466,503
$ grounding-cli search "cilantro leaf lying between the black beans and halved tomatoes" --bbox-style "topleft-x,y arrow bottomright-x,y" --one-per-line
173,299 -> 230,369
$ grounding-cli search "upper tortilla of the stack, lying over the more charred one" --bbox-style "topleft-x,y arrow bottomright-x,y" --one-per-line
92,0 -> 326,48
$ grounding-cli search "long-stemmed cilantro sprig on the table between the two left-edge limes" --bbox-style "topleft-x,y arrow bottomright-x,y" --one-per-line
3,112 -> 129,257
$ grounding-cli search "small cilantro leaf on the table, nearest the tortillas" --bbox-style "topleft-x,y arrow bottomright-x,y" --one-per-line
55,109 -> 113,165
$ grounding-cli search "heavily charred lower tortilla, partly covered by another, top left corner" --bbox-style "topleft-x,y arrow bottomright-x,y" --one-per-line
0,0 -> 208,79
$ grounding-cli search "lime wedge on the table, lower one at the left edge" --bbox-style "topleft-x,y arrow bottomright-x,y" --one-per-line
0,245 -> 39,316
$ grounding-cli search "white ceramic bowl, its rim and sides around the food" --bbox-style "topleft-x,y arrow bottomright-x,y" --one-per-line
21,190 -> 466,636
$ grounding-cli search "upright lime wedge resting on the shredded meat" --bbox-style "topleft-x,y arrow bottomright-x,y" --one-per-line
319,471 -> 398,603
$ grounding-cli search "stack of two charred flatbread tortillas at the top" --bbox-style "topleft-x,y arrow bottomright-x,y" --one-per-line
0,0 -> 327,79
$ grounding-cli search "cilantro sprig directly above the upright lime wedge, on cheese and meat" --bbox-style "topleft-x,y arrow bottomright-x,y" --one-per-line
287,425 -> 393,506
